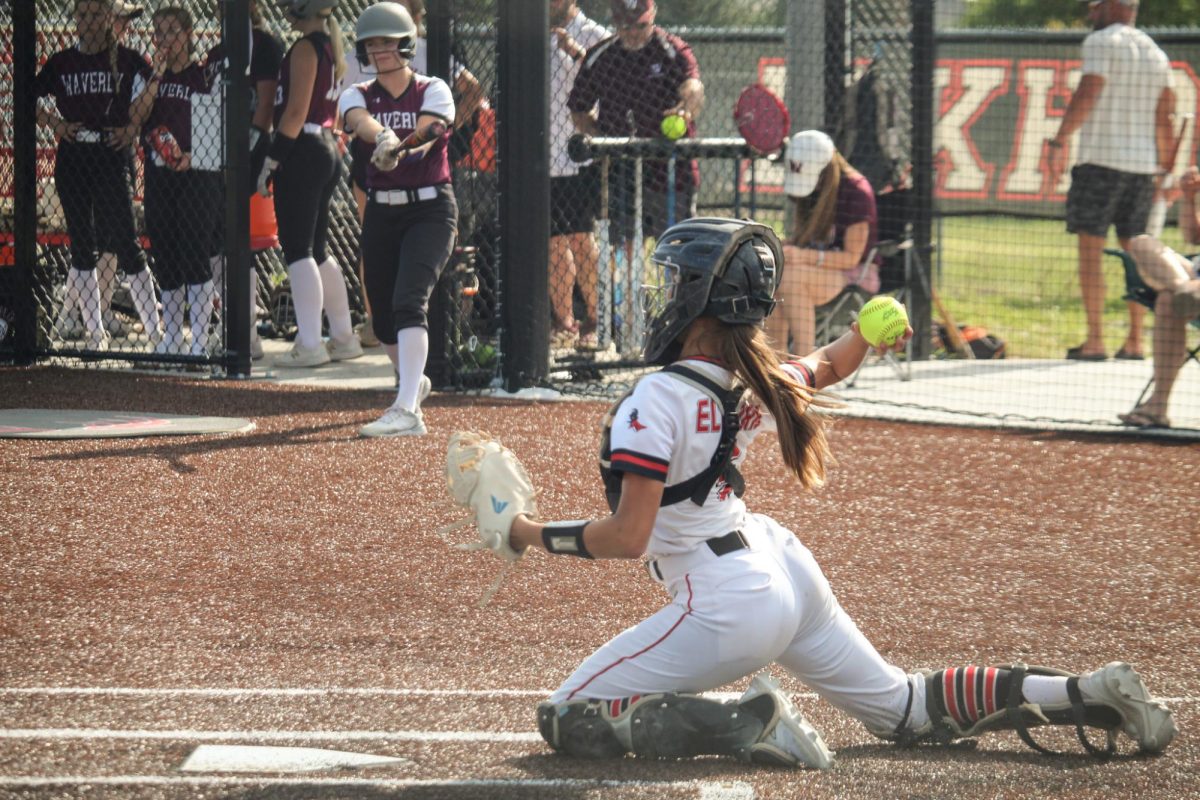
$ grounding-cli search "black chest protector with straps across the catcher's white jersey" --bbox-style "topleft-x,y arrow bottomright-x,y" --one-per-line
600,363 -> 745,512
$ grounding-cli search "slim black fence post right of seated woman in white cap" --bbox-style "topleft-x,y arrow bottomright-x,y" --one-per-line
910,0 -> 937,360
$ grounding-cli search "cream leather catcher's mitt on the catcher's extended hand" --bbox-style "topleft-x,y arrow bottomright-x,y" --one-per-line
446,431 -> 538,561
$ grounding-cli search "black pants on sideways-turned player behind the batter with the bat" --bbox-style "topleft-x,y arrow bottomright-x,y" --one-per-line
274,128 -> 342,264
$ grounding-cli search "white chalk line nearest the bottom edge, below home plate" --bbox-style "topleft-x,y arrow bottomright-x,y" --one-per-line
0,775 -> 755,800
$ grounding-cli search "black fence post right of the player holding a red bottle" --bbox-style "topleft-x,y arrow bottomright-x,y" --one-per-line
221,0 -> 254,378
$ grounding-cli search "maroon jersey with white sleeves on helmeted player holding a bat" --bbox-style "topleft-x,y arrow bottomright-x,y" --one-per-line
345,73 -> 452,192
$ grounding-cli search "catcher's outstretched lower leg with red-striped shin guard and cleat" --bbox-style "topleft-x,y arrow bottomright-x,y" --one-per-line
899,664 -> 1175,758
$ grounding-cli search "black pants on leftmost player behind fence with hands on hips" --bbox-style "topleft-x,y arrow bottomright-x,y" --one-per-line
54,142 -> 146,275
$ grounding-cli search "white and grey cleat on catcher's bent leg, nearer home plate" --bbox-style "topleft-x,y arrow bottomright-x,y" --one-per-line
738,672 -> 834,770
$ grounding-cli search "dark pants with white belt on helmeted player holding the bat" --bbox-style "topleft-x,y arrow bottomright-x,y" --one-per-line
362,184 -> 458,344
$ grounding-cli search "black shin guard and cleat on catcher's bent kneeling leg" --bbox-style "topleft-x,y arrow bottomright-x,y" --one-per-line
538,691 -> 833,768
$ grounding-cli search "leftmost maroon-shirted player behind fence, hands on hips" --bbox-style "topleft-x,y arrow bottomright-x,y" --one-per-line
35,0 -> 160,350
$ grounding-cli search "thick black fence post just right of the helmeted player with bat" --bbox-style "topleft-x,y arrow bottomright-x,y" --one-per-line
497,0 -> 550,391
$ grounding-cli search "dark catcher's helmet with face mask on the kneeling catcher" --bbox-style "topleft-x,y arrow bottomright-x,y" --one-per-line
642,217 -> 784,365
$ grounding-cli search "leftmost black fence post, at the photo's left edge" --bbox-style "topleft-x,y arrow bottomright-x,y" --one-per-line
11,2 -> 37,366
